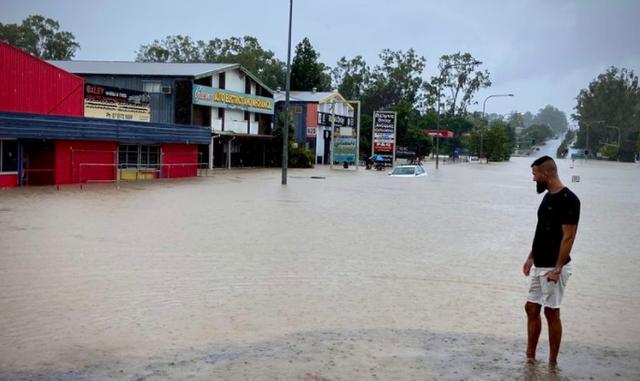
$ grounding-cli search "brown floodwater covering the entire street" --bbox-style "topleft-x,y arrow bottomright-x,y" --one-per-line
0,158 -> 640,380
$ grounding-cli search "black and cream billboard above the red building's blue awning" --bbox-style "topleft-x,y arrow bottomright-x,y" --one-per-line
84,83 -> 151,122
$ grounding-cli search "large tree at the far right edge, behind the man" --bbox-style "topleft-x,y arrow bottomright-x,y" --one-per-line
572,67 -> 640,161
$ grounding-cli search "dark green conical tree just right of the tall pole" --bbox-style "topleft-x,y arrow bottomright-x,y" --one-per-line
291,37 -> 331,91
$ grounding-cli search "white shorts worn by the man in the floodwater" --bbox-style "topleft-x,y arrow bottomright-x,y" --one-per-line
527,263 -> 572,308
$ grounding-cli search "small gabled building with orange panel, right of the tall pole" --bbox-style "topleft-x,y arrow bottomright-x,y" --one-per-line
274,91 -> 356,164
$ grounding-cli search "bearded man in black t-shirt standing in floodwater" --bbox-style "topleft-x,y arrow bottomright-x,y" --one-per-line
522,156 -> 580,365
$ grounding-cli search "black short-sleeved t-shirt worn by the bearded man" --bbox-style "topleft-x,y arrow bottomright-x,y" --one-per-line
531,187 -> 580,267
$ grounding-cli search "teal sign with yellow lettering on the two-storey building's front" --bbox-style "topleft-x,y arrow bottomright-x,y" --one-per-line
193,85 -> 273,114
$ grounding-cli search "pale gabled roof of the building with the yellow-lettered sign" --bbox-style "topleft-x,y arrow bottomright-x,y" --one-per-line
47,60 -> 274,94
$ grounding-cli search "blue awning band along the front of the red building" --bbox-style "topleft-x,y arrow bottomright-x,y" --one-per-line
0,112 -> 211,144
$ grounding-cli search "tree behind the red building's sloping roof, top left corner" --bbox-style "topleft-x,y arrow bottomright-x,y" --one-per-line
0,15 -> 80,60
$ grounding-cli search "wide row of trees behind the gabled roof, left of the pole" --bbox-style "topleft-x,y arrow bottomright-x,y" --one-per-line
136,35 -> 285,89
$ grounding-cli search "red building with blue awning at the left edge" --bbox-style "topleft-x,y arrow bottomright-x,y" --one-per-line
0,41 -> 210,188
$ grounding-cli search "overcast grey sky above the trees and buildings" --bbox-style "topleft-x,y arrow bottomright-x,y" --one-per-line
0,0 -> 640,116
